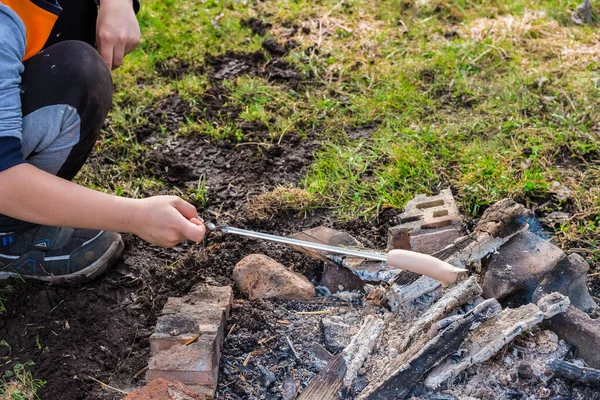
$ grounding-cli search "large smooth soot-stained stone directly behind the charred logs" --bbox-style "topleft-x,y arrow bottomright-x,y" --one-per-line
483,232 -> 566,303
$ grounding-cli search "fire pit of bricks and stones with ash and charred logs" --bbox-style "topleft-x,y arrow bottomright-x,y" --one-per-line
127,191 -> 600,400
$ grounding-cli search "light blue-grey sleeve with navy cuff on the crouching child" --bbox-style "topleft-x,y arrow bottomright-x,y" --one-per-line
0,4 -> 25,171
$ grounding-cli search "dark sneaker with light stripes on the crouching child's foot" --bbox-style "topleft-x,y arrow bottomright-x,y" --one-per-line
0,225 -> 124,285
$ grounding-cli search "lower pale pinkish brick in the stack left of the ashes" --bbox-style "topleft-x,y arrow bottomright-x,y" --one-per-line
146,334 -> 220,388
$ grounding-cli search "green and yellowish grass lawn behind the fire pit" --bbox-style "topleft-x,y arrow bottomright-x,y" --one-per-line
82,0 -> 600,260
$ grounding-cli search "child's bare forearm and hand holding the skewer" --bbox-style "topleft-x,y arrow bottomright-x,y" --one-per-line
0,164 -> 205,247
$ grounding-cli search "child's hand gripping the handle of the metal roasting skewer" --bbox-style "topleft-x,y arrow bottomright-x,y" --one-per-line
132,196 -> 206,247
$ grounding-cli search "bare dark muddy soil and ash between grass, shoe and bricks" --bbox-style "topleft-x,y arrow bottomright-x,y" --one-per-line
0,21 -> 589,400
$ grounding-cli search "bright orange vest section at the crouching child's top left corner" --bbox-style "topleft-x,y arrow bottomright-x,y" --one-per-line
0,0 -> 62,61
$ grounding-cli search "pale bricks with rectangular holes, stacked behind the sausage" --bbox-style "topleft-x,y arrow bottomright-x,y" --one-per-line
387,189 -> 463,254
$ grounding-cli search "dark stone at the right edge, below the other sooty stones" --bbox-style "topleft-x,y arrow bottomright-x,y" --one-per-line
542,306 -> 600,368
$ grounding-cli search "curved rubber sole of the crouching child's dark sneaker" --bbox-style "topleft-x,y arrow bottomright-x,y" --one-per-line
0,236 -> 125,286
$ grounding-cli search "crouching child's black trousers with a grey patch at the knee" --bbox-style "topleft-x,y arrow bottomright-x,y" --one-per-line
0,0 -> 113,232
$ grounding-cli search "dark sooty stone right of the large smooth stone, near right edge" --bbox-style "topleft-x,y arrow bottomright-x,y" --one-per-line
533,254 -> 598,313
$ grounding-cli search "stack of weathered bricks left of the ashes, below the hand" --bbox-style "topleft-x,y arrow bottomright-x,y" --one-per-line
146,285 -> 233,398
